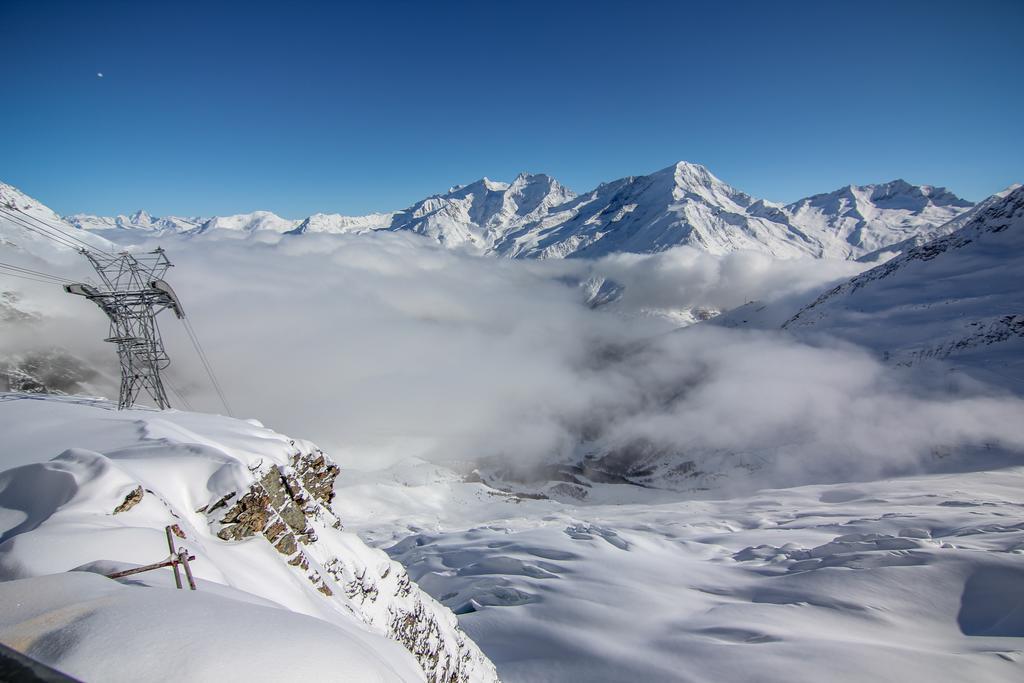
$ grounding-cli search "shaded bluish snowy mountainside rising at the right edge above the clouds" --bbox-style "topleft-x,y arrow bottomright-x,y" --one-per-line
783,187 -> 1024,392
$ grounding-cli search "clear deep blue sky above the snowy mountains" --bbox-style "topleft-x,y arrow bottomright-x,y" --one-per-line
0,0 -> 1024,217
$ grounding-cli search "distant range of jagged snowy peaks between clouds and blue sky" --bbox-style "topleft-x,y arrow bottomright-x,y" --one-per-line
37,162 -> 999,259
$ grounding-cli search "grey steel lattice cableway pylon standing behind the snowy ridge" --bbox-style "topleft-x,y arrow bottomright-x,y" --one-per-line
65,248 -> 185,410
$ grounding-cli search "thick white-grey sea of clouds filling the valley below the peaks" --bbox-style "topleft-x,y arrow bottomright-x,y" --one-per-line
0,232 -> 1024,484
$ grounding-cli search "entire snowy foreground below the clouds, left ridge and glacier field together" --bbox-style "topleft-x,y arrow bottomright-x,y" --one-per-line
0,394 -> 1024,681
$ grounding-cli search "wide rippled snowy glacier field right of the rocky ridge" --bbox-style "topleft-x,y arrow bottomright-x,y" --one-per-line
336,456 -> 1024,682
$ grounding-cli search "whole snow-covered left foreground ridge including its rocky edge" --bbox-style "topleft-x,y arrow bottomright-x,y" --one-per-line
0,394 -> 496,682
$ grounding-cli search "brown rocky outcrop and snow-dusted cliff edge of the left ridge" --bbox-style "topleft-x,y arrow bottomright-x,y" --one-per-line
200,446 -> 498,683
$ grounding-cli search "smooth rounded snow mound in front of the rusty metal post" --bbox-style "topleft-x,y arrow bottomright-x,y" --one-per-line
0,571 -> 423,683
